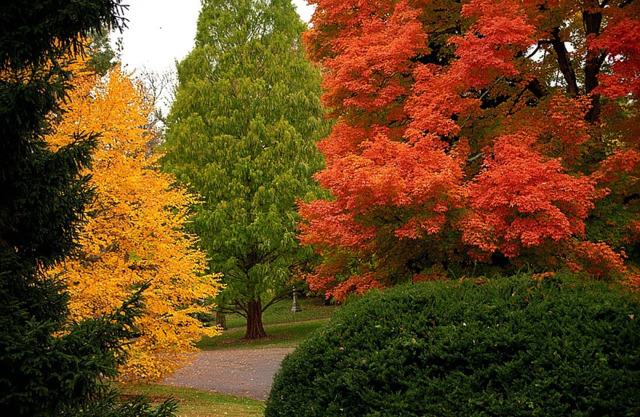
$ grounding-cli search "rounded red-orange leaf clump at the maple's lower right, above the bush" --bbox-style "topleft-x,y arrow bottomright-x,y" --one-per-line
463,132 -> 595,257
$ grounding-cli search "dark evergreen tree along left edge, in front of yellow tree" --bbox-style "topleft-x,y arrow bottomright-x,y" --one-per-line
0,0 -> 173,416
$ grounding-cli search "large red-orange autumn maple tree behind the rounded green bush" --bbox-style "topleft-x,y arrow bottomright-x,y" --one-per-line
301,0 -> 640,299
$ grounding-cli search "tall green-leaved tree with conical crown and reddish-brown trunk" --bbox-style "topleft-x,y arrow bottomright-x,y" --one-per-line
164,0 -> 327,339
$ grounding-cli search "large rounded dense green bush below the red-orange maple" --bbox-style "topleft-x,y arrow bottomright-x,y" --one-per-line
265,276 -> 640,417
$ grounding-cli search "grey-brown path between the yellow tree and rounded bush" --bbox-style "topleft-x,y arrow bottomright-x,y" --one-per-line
162,348 -> 293,400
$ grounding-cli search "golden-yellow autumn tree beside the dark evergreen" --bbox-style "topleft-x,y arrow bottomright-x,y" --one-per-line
48,62 -> 220,381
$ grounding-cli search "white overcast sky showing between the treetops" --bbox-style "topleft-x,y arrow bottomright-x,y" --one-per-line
111,0 -> 313,73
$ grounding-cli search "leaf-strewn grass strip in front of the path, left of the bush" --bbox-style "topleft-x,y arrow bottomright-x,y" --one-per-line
120,384 -> 264,417
